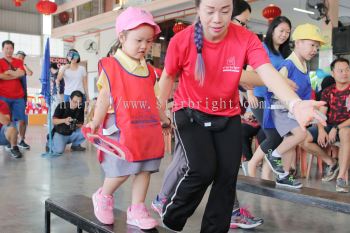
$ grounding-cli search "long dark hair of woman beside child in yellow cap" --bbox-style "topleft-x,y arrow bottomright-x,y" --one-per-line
264,16 -> 292,58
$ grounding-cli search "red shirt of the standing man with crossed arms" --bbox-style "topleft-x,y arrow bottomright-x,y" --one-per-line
0,58 -> 24,99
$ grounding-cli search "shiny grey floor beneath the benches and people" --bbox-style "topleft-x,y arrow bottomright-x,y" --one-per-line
0,127 -> 350,233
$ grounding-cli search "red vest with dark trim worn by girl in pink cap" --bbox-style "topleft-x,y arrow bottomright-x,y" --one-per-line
99,57 -> 164,162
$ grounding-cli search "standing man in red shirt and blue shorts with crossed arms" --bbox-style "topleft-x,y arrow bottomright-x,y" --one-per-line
0,40 -> 30,149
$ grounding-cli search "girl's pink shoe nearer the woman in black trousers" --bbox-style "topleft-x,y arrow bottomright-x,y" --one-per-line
126,203 -> 158,230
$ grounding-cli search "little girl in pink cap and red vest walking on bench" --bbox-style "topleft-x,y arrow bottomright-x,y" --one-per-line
86,7 -> 171,229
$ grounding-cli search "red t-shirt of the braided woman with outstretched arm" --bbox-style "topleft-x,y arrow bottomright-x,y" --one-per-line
165,23 -> 270,116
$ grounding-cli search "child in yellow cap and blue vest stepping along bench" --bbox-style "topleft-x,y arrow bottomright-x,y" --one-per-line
264,24 -> 325,188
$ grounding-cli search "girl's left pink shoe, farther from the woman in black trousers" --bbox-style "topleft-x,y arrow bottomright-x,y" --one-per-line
92,188 -> 114,225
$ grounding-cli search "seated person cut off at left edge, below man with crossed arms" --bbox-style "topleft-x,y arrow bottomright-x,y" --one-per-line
0,100 -> 22,158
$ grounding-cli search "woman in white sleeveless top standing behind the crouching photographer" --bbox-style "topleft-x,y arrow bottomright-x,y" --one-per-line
56,49 -> 89,103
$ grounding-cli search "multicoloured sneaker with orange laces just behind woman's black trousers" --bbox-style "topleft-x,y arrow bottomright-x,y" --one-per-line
230,208 -> 264,229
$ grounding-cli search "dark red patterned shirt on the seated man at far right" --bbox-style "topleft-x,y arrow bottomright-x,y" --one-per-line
321,84 -> 350,125
